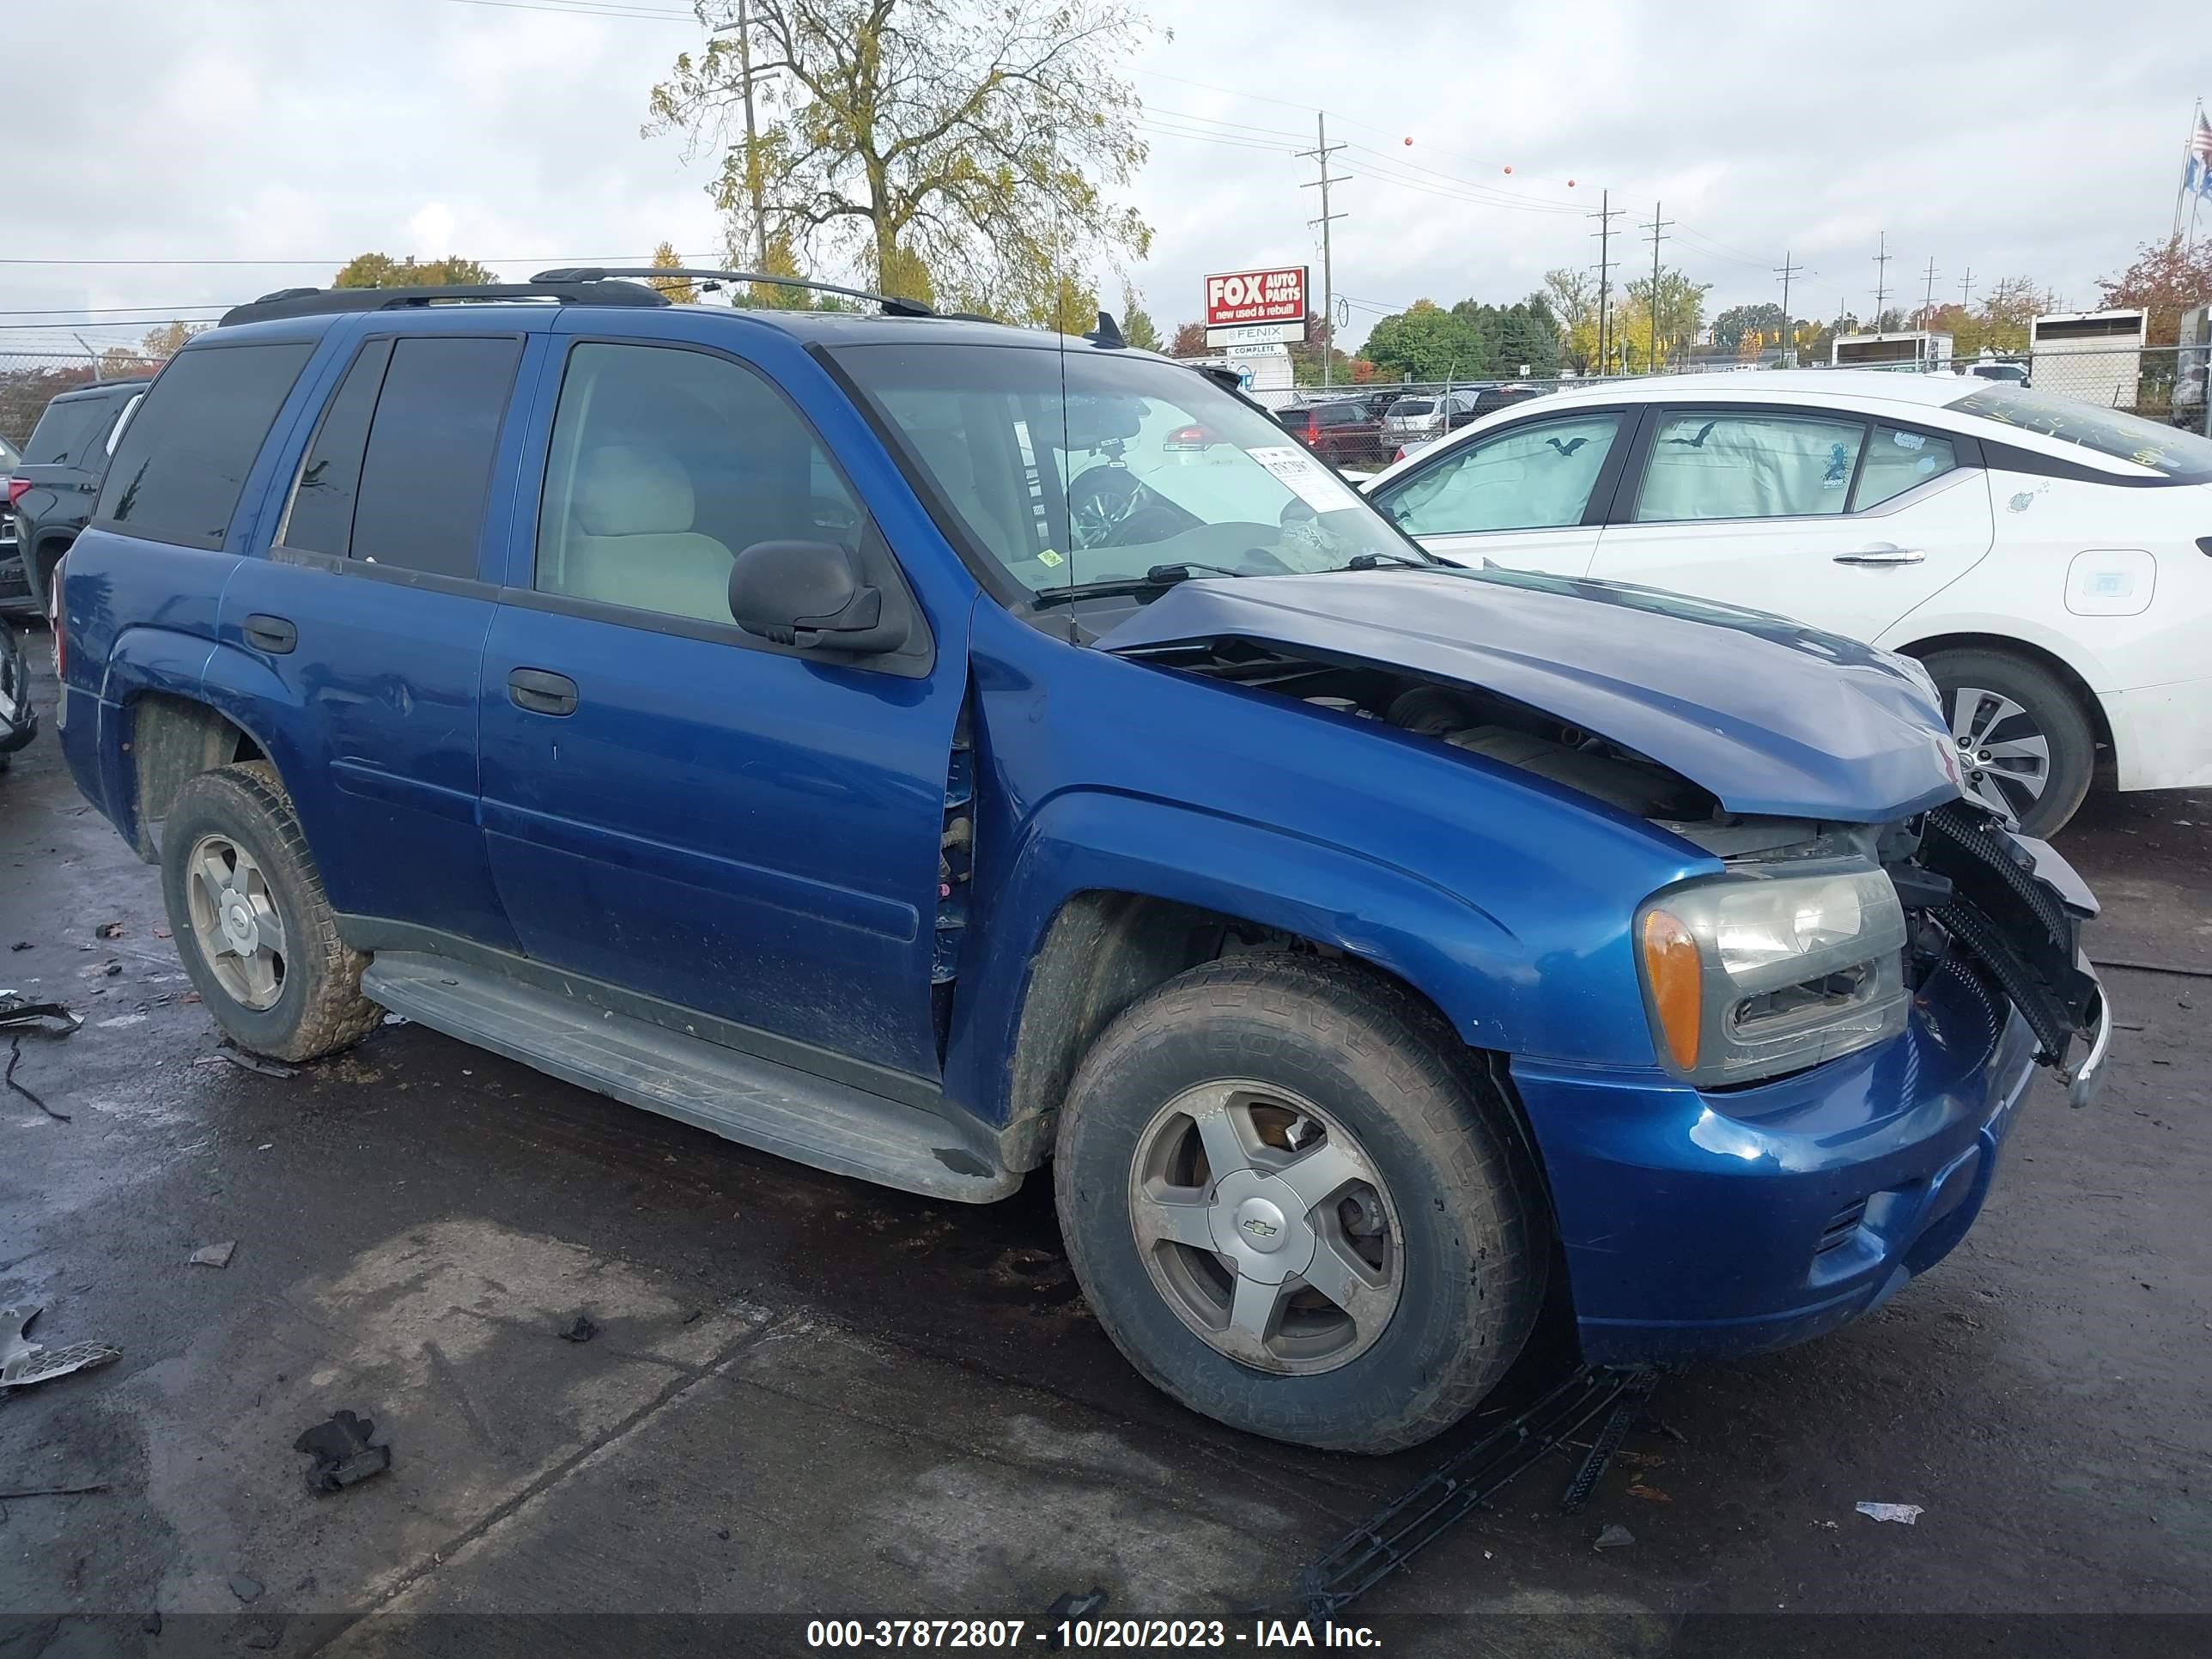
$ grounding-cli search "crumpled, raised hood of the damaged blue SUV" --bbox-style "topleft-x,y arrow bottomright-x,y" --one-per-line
1097,566 -> 1960,823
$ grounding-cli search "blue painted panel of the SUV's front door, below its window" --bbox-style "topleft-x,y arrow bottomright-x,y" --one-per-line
483,604 -> 963,1078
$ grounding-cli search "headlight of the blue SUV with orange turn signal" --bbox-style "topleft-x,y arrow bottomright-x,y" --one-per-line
1637,860 -> 1909,1086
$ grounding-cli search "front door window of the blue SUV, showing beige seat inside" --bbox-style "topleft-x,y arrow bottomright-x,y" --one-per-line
535,345 -> 860,622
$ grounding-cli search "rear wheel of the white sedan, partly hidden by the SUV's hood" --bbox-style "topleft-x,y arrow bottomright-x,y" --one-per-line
1924,648 -> 2097,836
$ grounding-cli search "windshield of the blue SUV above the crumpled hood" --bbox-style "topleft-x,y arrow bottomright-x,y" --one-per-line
836,343 -> 1425,592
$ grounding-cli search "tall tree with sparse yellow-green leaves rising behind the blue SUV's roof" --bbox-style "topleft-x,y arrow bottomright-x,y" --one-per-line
648,0 -> 1152,312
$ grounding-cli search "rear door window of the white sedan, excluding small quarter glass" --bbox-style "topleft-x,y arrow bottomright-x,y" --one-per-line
1635,410 -> 1867,522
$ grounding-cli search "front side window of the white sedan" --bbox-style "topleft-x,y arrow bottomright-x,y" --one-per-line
1378,414 -> 1621,535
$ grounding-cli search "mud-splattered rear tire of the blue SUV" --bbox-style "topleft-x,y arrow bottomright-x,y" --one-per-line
161,761 -> 383,1060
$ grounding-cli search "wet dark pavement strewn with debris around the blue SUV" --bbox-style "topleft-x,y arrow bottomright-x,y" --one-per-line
0,639 -> 2212,1659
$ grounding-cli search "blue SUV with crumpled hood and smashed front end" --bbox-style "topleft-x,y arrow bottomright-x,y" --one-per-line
60,270 -> 2111,1451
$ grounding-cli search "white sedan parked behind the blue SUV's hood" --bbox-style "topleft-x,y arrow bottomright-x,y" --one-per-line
1360,369 -> 2212,834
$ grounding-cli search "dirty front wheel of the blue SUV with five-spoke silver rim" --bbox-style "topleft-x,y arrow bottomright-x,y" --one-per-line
1055,956 -> 1548,1451
